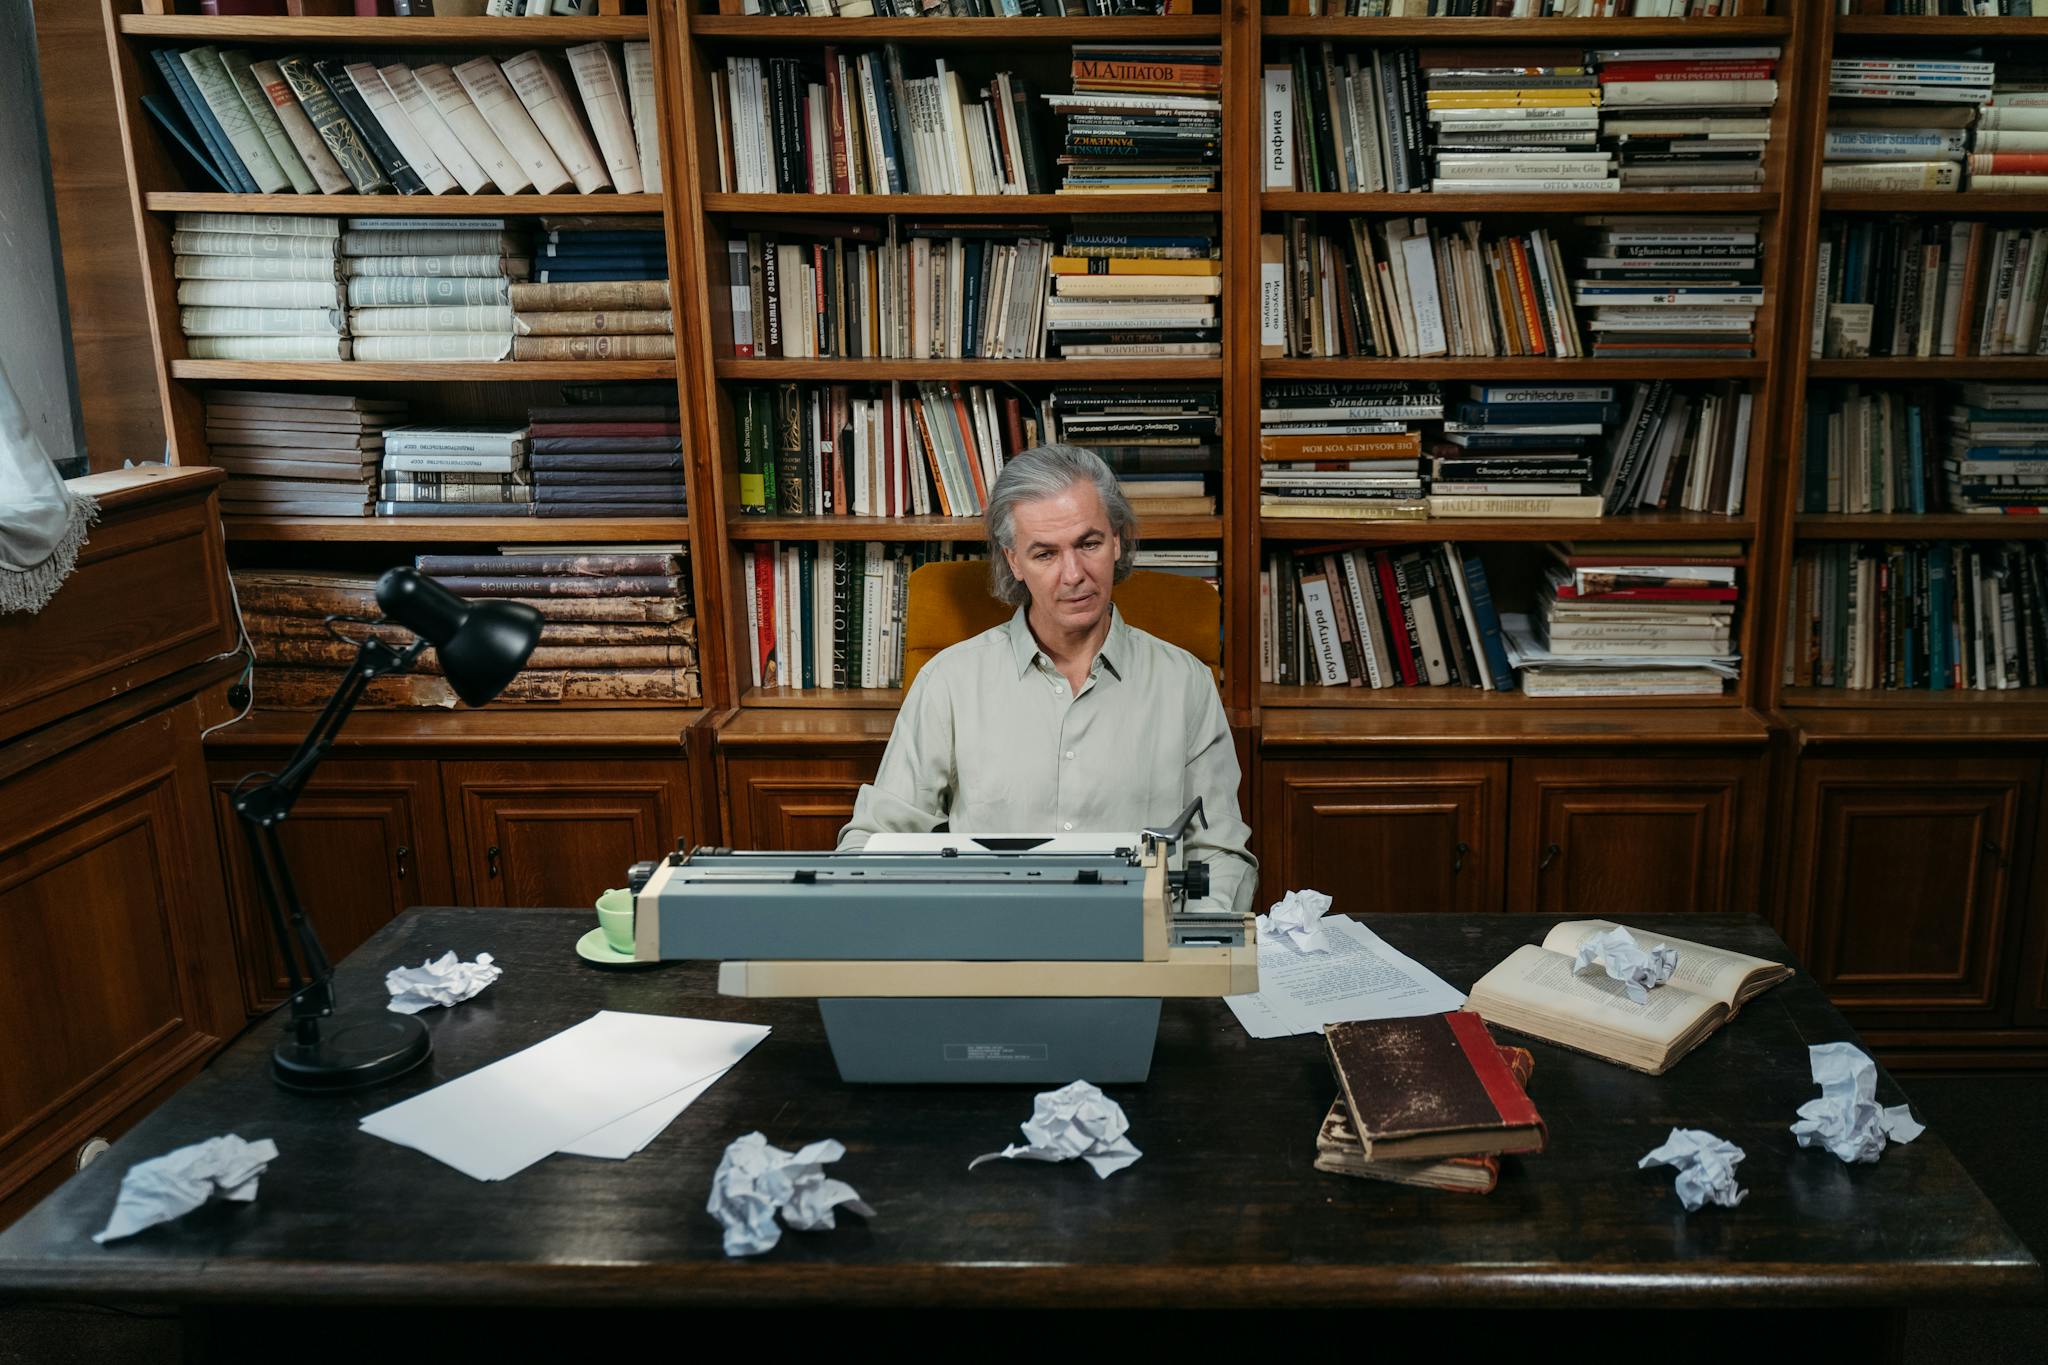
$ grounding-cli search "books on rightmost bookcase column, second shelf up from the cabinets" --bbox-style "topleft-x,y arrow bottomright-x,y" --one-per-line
1800,383 -> 2048,516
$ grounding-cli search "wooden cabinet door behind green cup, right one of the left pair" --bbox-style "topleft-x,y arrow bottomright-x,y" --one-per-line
440,753 -> 694,905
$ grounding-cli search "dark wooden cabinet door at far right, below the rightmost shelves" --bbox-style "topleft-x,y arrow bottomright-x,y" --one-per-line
1786,757 -> 2038,1027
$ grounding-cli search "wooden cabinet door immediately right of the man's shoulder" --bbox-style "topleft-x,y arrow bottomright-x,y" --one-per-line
1257,759 -> 1507,915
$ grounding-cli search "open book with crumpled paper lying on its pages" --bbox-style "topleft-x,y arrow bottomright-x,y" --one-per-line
1464,919 -> 1792,1076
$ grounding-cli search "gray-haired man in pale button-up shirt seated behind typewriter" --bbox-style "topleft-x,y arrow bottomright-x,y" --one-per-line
840,446 -> 1257,911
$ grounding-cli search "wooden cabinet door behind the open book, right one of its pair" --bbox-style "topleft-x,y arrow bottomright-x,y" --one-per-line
1507,755 -> 1763,919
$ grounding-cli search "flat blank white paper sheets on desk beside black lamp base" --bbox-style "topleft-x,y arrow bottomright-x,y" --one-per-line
362,1009 -> 768,1181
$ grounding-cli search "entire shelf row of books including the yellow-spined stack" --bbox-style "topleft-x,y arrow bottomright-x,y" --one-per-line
1262,43 -> 1780,194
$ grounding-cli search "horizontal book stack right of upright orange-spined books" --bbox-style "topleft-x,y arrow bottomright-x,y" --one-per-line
1573,215 -> 1763,360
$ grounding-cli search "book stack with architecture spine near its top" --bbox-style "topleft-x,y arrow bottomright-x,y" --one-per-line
1430,385 -> 1620,516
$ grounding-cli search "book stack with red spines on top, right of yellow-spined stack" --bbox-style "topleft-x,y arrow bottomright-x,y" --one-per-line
1593,45 -> 1780,190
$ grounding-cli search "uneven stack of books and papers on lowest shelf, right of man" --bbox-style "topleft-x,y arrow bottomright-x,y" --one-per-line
1501,540 -> 1743,698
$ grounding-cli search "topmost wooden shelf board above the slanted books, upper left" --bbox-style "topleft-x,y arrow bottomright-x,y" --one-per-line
117,14 -> 647,49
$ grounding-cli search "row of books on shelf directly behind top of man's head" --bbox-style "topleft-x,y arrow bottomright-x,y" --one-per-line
733,381 -> 1223,516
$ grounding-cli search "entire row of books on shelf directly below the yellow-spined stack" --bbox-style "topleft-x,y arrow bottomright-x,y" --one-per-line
1260,215 -> 1763,358
